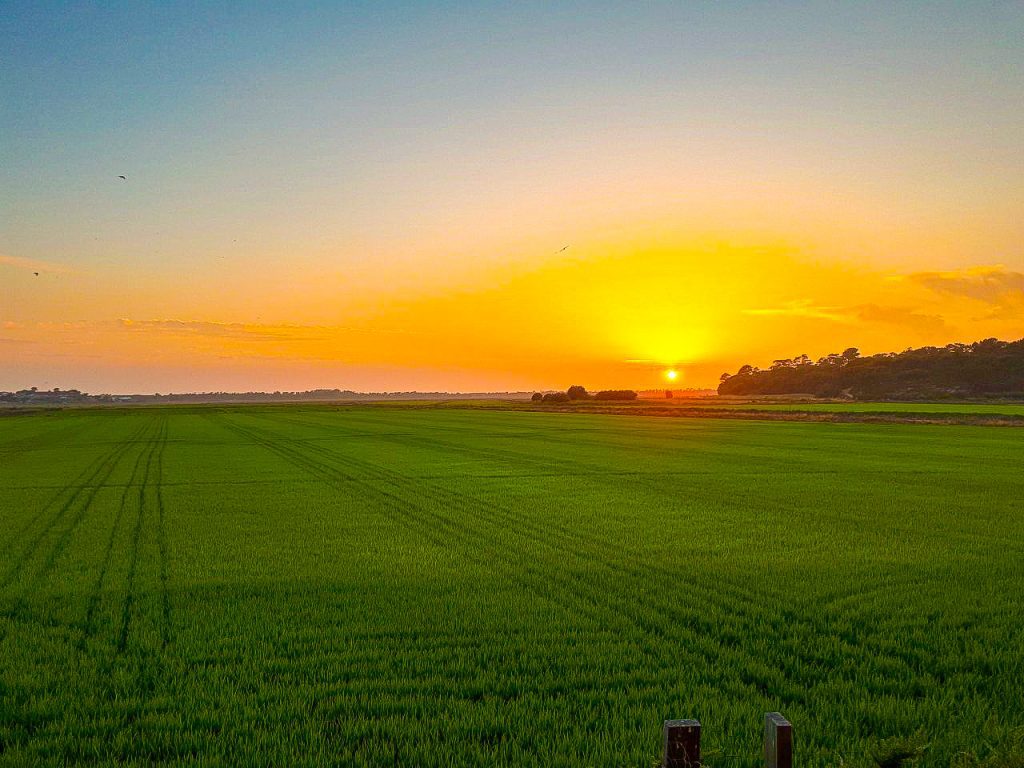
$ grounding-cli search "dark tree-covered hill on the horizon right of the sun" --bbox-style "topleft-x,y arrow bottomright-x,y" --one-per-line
718,339 -> 1024,400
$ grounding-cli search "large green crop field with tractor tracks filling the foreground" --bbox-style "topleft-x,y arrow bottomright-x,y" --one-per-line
0,407 -> 1024,768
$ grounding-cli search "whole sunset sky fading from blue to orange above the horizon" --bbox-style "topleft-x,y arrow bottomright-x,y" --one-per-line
0,1 -> 1024,393
